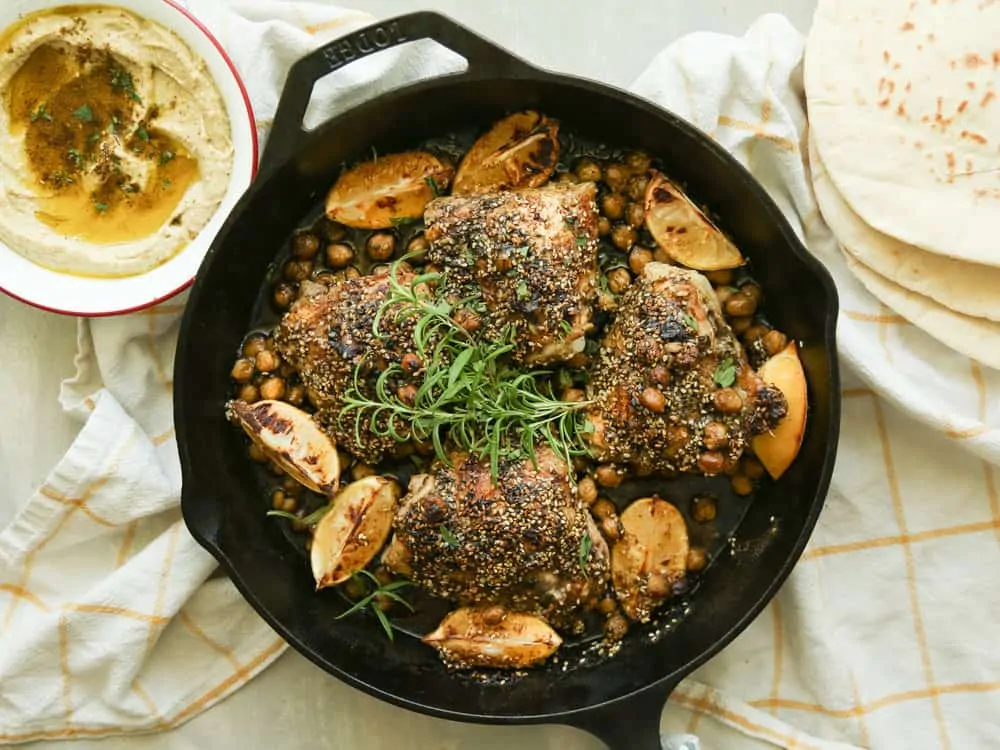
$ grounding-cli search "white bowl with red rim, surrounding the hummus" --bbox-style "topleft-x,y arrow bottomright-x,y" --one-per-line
0,0 -> 257,317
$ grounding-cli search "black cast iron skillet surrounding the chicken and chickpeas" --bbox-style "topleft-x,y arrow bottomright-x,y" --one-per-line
174,12 -> 840,750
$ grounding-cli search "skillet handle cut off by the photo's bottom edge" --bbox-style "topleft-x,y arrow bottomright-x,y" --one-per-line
566,682 -> 677,750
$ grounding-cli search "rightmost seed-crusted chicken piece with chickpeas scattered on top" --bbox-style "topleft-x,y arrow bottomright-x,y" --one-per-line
589,263 -> 788,474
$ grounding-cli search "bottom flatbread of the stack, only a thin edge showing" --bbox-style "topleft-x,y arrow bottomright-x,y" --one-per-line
841,248 -> 1000,369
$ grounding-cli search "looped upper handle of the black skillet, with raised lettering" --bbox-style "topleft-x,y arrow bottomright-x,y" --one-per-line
260,11 -> 537,171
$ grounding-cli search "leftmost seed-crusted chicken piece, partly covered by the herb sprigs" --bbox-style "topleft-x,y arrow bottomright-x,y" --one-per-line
274,272 -> 414,463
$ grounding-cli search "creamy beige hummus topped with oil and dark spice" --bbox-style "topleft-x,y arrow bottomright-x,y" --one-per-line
0,6 -> 233,277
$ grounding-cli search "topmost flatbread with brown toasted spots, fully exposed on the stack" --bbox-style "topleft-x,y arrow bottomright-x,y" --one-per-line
804,0 -> 1000,265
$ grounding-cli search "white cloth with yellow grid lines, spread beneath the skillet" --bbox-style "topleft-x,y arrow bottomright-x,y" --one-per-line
0,0 -> 1000,750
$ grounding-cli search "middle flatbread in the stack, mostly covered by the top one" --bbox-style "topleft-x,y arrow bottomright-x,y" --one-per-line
808,133 -> 1000,321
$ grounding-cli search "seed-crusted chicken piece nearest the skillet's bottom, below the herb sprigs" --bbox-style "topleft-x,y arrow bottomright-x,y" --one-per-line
383,446 -> 610,630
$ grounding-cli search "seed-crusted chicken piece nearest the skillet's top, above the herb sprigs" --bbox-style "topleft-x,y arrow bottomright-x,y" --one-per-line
424,183 -> 598,365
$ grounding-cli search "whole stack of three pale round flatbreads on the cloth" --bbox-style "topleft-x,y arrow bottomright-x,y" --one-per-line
805,0 -> 1000,368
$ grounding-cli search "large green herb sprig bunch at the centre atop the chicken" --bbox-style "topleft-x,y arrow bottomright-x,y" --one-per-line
340,257 -> 590,479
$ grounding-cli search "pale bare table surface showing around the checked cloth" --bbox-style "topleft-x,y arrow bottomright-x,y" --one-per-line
0,0 -> 815,750
